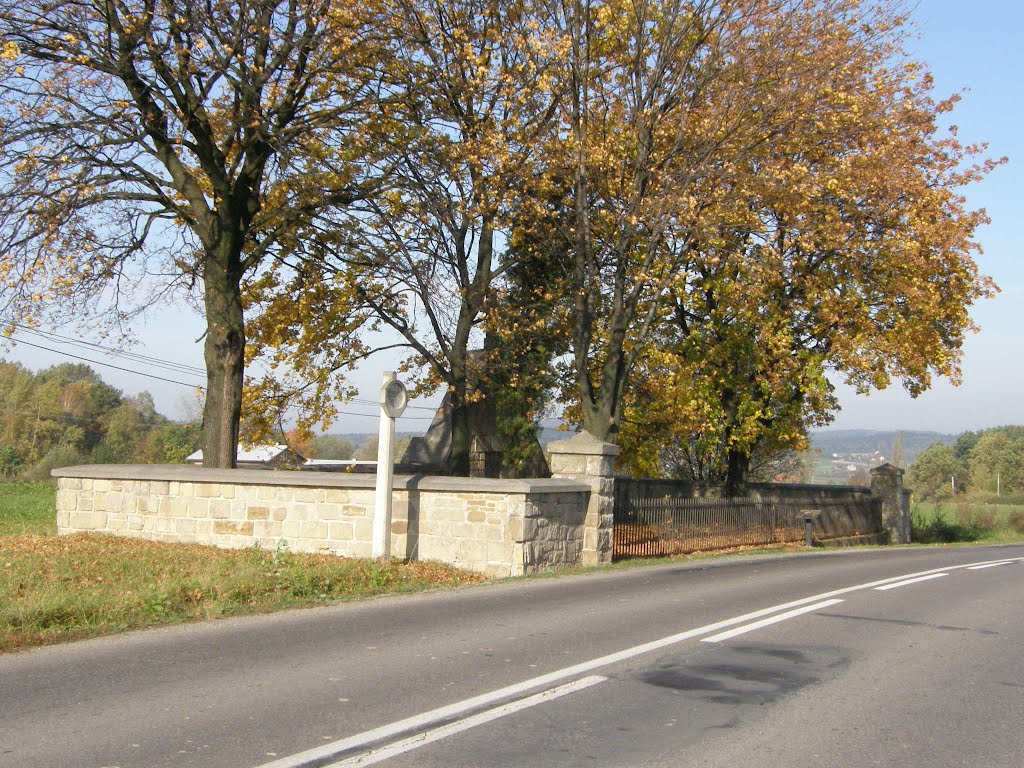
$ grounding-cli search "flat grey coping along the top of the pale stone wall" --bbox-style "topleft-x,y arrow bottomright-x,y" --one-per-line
50,464 -> 591,495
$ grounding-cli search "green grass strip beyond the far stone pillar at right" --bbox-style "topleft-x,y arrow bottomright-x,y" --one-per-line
910,501 -> 1024,544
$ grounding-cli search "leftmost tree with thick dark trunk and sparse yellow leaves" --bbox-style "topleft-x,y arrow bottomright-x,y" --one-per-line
0,0 -> 375,467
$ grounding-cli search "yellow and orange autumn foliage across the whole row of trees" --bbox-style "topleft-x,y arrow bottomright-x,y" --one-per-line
0,0 -> 997,487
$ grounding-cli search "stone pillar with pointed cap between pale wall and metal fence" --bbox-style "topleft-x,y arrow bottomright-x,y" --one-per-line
548,432 -> 618,565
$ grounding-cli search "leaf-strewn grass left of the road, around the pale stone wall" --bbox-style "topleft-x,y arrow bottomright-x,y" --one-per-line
0,483 -> 483,652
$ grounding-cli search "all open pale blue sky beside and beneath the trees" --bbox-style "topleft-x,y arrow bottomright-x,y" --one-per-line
0,0 -> 1024,433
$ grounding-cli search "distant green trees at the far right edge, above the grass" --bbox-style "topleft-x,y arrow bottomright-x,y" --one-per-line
906,425 -> 1024,502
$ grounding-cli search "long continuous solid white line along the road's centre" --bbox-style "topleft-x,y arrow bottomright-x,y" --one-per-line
251,558 -> 1024,768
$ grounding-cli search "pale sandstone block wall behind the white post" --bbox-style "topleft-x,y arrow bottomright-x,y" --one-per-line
53,465 -> 591,577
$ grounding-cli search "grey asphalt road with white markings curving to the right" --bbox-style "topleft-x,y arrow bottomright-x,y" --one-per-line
0,546 -> 1024,768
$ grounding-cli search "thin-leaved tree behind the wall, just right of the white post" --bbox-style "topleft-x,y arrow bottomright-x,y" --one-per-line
241,0 -> 556,474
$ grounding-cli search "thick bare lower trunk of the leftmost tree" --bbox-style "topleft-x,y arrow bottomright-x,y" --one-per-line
202,247 -> 246,469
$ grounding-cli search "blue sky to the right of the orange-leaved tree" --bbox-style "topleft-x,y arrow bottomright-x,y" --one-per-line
834,0 -> 1024,432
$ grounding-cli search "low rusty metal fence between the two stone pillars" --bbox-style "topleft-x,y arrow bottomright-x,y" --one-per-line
612,492 -> 882,558
